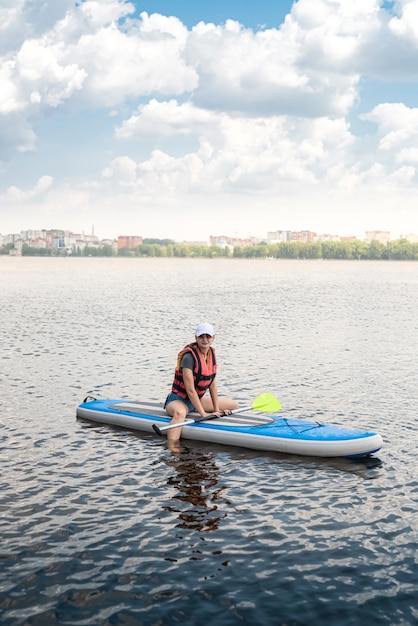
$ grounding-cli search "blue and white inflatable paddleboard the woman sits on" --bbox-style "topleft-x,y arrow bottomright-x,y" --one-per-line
77,397 -> 383,457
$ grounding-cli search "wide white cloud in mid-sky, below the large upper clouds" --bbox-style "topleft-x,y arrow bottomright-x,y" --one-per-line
113,100 -> 355,193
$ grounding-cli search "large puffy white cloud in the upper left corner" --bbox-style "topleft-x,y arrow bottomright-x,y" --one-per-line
0,0 -> 196,114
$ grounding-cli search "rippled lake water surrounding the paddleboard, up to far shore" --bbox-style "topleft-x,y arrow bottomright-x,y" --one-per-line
0,257 -> 418,626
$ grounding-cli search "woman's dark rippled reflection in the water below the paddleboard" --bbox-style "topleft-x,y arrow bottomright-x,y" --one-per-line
165,448 -> 226,532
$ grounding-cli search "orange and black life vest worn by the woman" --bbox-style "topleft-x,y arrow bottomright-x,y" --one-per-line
171,343 -> 216,399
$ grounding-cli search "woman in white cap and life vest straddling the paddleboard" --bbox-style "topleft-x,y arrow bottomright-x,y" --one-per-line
165,322 -> 238,443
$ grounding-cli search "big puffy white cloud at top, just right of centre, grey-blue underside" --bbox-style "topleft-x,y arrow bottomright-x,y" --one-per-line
186,11 -> 359,117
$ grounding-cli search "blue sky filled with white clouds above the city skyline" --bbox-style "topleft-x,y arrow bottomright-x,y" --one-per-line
0,0 -> 418,241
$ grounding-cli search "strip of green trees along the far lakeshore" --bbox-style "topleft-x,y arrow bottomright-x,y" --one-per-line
0,239 -> 418,261
